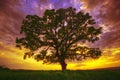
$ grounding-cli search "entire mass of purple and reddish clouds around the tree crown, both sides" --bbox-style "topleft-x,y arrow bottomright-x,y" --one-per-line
0,0 -> 120,47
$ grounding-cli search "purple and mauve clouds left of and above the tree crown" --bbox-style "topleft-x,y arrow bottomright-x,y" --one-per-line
0,0 -> 81,44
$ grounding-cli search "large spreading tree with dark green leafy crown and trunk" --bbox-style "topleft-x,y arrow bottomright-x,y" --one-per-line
16,7 -> 101,70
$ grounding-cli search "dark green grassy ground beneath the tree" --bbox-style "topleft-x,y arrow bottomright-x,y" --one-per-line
0,70 -> 120,80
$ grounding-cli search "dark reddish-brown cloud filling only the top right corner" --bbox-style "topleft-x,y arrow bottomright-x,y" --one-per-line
84,0 -> 120,24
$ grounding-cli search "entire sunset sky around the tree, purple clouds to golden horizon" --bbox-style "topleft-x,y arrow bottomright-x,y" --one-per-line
0,0 -> 120,70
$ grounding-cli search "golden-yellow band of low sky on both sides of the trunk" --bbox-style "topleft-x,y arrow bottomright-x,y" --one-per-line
0,41 -> 120,70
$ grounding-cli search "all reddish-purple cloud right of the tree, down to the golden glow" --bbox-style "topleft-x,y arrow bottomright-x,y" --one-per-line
83,0 -> 120,47
